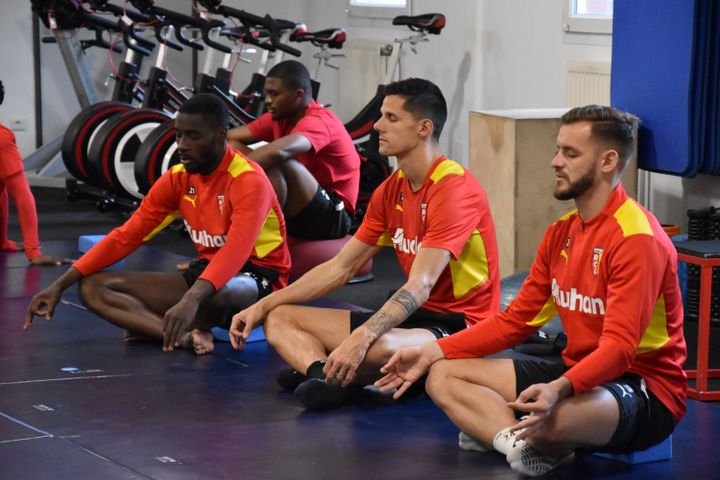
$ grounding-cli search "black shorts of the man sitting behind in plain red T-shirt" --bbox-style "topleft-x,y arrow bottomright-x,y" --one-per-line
285,185 -> 352,240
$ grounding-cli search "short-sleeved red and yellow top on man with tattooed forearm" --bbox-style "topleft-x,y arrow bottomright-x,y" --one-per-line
355,156 -> 500,325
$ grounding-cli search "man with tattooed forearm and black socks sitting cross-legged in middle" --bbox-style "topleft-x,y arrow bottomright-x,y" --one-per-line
230,79 -> 500,409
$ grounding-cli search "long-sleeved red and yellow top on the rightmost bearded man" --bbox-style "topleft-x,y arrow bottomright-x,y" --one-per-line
439,185 -> 687,420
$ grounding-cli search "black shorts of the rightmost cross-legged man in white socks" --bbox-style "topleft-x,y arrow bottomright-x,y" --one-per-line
513,360 -> 677,453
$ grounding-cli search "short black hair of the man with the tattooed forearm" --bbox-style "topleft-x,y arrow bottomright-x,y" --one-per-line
384,78 -> 447,142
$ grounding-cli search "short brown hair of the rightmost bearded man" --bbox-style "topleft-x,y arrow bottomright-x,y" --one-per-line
560,105 -> 639,172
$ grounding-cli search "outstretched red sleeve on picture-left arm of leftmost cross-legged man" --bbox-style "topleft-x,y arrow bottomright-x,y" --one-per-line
73,170 -> 180,276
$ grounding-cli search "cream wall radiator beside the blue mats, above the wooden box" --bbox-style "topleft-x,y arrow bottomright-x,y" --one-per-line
565,62 -> 610,107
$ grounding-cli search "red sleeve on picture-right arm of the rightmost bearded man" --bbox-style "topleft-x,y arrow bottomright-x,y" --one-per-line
565,234 -> 666,394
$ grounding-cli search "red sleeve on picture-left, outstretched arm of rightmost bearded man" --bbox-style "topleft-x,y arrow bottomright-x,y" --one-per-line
438,227 -> 557,359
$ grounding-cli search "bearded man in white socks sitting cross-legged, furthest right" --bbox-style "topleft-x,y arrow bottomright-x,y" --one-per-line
376,105 -> 687,476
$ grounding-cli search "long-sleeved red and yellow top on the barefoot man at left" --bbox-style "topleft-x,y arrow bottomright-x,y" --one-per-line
73,148 -> 290,289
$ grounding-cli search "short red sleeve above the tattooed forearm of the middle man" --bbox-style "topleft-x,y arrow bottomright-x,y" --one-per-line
422,175 -> 489,259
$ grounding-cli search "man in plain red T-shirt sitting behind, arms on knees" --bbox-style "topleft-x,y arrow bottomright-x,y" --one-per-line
228,60 -> 360,239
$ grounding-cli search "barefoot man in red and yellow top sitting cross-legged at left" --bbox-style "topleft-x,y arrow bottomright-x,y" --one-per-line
24,94 -> 290,354
